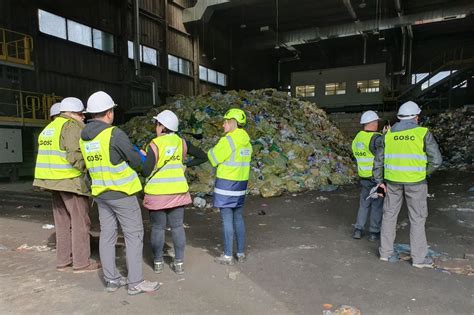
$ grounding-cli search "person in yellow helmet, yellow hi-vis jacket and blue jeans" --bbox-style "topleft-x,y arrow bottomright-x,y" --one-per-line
207,108 -> 252,265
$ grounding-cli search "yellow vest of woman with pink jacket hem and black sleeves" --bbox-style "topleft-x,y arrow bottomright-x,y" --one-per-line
145,133 -> 189,195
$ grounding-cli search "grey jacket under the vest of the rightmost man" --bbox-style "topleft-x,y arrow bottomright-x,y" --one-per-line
373,119 -> 443,185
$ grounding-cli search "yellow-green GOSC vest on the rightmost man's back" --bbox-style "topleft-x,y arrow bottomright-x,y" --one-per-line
384,127 -> 428,183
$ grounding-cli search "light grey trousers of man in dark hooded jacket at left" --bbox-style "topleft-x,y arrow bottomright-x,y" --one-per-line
96,196 -> 143,288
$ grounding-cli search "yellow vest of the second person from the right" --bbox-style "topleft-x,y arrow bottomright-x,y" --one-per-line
352,130 -> 379,178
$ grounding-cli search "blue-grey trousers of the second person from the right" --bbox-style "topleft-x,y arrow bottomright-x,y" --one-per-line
354,179 -> 383,233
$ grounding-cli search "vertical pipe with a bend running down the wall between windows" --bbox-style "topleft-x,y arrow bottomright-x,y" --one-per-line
133,0 -> 158,106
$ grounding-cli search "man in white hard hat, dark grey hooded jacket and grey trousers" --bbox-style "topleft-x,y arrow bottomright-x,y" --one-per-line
80,91 -> 160,295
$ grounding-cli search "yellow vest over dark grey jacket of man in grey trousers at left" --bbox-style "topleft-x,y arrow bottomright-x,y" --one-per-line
79,127 -> 142,197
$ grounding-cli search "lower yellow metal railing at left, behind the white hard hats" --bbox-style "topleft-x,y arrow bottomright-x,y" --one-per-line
0,87 -> 62,125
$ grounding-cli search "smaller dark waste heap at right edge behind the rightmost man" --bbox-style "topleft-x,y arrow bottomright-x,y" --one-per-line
423,107 -> 474,169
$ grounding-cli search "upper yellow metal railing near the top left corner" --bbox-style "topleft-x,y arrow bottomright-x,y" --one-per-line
0,28 -> 33,66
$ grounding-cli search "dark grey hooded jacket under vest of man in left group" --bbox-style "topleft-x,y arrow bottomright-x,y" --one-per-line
81,119 -> 141,200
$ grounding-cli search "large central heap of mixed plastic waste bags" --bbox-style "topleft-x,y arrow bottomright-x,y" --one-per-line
123,89 -> 356,197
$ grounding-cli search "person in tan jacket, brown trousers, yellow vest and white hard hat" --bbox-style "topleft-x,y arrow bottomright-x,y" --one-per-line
33,97 -> 100,273
